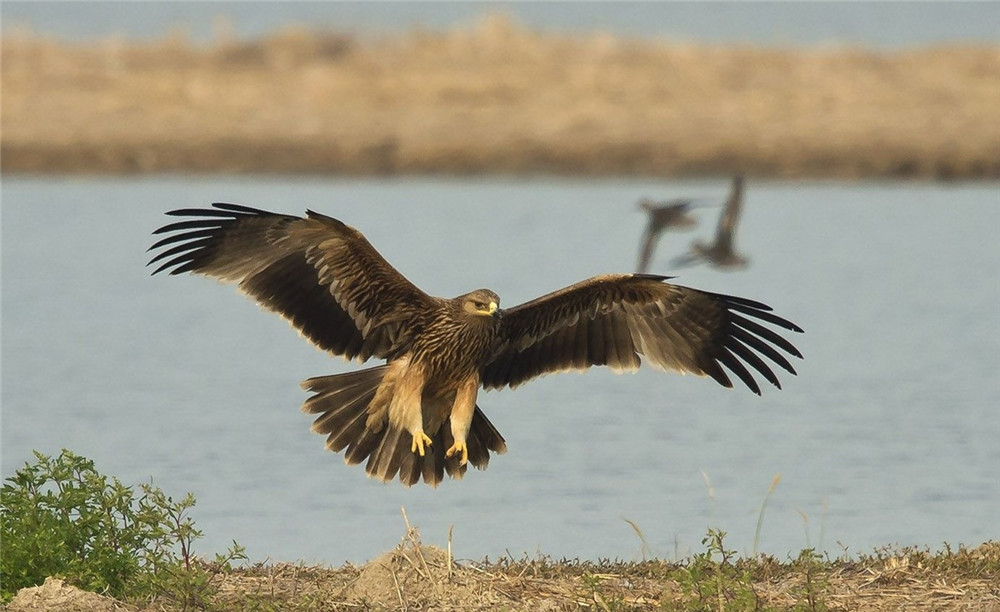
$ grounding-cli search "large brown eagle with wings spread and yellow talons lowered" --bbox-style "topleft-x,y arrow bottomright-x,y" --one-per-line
147,203 -> 802,486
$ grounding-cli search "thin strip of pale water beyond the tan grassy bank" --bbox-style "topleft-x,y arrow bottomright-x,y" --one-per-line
2,1 -> 1000,48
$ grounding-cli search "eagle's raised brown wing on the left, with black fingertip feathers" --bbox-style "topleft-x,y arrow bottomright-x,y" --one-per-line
147,203 -> 435,361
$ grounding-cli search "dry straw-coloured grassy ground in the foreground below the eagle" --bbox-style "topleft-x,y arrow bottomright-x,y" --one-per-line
7,529 -> 1000,612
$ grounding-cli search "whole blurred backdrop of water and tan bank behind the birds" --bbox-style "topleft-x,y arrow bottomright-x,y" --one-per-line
0,2 -> 1000,563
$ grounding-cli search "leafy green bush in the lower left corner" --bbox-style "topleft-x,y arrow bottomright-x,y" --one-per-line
0,449 -> 246,608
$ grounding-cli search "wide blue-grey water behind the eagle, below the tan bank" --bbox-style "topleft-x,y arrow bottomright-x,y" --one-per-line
0,177 -> 1000,564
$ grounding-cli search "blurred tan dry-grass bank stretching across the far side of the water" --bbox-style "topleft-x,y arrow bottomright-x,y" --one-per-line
2,16 -> 1000,178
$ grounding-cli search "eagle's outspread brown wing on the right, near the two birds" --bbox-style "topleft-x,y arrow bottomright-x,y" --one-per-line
482,274 -> 802,395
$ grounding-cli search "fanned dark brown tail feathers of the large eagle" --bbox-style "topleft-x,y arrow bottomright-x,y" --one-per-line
294,365 -> 507,486
